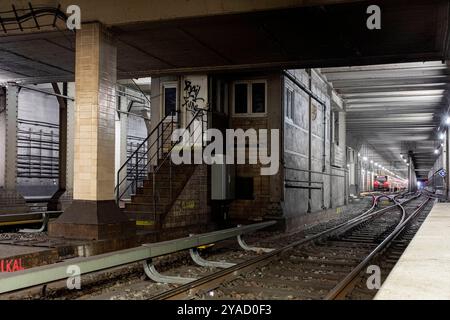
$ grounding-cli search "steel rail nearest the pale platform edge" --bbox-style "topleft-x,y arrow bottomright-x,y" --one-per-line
325,197 -> 431,300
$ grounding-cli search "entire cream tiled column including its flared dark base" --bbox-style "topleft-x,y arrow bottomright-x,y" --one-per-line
49,23 -> 134,239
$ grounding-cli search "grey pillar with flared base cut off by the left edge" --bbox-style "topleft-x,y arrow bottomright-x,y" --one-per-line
0,84 -> 29,214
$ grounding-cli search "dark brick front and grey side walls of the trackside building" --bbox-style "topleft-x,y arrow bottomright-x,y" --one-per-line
152,70 -> 347,230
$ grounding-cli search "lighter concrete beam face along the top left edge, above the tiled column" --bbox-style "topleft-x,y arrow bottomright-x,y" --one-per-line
0,0 -> 363,32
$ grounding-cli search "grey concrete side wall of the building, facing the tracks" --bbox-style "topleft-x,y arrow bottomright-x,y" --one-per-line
283,70 -> 345,218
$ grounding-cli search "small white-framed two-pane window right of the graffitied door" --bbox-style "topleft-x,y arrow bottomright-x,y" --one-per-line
233,80 -> 267,116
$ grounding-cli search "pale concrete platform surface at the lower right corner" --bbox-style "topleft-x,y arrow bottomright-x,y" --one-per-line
375,203 -> 450,300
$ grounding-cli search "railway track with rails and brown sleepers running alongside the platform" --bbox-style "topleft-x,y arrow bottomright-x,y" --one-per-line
152,195 -> 432,300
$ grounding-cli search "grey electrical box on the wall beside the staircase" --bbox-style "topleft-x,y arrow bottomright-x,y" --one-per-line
211,154 -> 236,200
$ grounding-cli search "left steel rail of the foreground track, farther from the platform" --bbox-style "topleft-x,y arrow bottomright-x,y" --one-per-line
151,196 -> 419,300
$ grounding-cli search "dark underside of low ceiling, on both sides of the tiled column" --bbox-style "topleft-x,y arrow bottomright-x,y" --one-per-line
0,0 -> 449,82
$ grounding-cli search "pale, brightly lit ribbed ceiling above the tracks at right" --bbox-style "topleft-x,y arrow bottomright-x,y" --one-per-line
322,61 -> 450,178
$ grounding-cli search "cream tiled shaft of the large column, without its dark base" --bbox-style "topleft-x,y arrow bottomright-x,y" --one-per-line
74,23 -> 117,200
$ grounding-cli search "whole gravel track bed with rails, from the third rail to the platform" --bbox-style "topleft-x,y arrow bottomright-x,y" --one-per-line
1,194 -> 431,299
